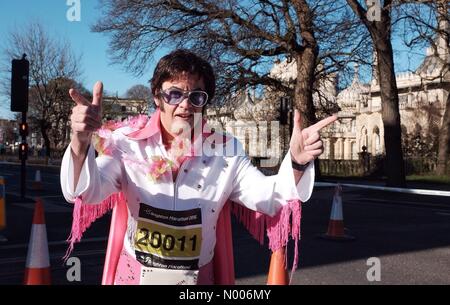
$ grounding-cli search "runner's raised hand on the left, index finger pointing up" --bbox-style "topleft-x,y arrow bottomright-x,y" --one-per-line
69,82 -> 103,154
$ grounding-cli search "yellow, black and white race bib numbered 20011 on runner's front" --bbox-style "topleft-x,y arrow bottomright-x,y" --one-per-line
134,203 -> 202,284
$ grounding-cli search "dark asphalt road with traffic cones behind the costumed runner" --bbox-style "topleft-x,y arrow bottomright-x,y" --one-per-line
0,163 -> 450,285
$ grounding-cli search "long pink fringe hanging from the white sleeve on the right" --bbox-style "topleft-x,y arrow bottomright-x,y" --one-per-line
232,199 -> 302,282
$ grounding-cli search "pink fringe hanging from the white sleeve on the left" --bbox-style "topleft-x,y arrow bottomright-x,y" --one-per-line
63,192 -> 125,261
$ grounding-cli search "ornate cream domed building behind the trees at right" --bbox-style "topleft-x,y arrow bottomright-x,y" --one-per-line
207,22 -> 450,164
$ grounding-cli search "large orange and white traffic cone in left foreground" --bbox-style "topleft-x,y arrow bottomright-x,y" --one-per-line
24,199 -> 50,285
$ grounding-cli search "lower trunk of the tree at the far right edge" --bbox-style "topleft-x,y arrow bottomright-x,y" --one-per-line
436,93 -> 450,175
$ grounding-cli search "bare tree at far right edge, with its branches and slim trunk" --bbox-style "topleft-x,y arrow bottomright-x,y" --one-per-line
401,0 -> 450,175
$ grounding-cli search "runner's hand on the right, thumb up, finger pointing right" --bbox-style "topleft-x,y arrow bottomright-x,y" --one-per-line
289,110 -> 337,164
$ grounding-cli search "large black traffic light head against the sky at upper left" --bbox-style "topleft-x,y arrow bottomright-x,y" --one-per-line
11,54 -> 30,112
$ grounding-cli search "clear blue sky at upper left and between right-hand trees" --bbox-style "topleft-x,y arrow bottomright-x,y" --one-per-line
0,0 -> 424,118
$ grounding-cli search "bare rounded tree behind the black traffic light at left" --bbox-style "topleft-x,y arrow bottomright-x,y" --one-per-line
0,23 -> 81,157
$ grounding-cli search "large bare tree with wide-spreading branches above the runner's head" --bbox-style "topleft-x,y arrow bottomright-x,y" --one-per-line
93,0 -> 370,130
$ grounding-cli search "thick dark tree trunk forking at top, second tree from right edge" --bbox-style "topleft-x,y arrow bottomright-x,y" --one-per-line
347,0 -> 405,187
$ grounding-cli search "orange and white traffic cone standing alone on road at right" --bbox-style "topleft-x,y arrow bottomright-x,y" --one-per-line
320,184 -> 355,241
